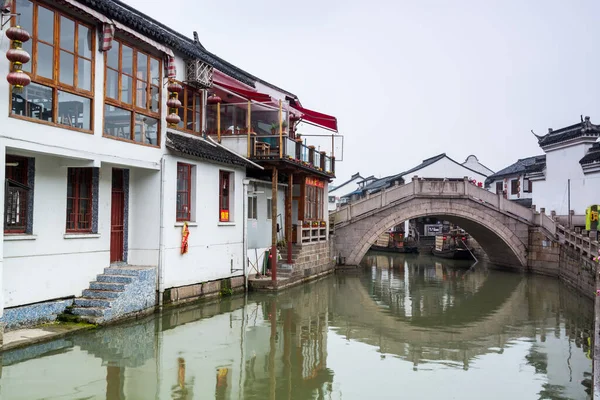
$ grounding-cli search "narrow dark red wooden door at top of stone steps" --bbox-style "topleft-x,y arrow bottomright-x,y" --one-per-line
110,168 -> 125,263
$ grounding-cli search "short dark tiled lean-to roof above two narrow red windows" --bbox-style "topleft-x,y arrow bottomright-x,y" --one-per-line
167,132 -> 251,167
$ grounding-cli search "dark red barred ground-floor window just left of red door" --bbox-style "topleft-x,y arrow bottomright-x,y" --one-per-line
67,168 -> 93,233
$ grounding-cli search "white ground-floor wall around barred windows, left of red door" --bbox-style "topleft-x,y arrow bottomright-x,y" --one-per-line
3,156 -> 111,307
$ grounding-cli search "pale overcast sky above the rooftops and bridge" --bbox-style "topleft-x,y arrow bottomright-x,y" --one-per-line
126,0 -> 600,184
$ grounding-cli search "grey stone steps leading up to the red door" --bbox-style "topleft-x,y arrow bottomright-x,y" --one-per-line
70,265 -> 156,324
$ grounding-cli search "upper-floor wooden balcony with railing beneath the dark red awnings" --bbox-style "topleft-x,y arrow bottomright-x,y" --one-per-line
206,102 -> 335,178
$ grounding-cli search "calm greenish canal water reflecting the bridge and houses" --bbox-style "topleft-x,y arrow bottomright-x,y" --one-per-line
0,253 -> 593,400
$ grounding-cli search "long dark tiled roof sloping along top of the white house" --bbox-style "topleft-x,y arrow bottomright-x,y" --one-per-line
80,0 -> 257,87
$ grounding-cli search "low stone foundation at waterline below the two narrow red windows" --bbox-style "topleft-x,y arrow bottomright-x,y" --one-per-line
163,276 -> 244,304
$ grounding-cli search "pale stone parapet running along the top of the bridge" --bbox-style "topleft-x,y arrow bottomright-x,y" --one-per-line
332,177 -> 544,228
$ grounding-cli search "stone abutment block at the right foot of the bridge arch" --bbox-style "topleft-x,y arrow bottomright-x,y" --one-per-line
527,227 -> 561,276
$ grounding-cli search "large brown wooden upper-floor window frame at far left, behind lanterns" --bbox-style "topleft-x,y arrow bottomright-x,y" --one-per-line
9,0 -> 96,134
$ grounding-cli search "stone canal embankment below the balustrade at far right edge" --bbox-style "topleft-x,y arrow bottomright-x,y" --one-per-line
559,246 -> 596,298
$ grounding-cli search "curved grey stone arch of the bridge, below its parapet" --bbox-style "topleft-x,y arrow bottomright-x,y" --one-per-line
336,197 -> 529,268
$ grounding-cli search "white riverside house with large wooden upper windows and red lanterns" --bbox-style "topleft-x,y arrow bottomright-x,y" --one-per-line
0,0 -> 337,340
